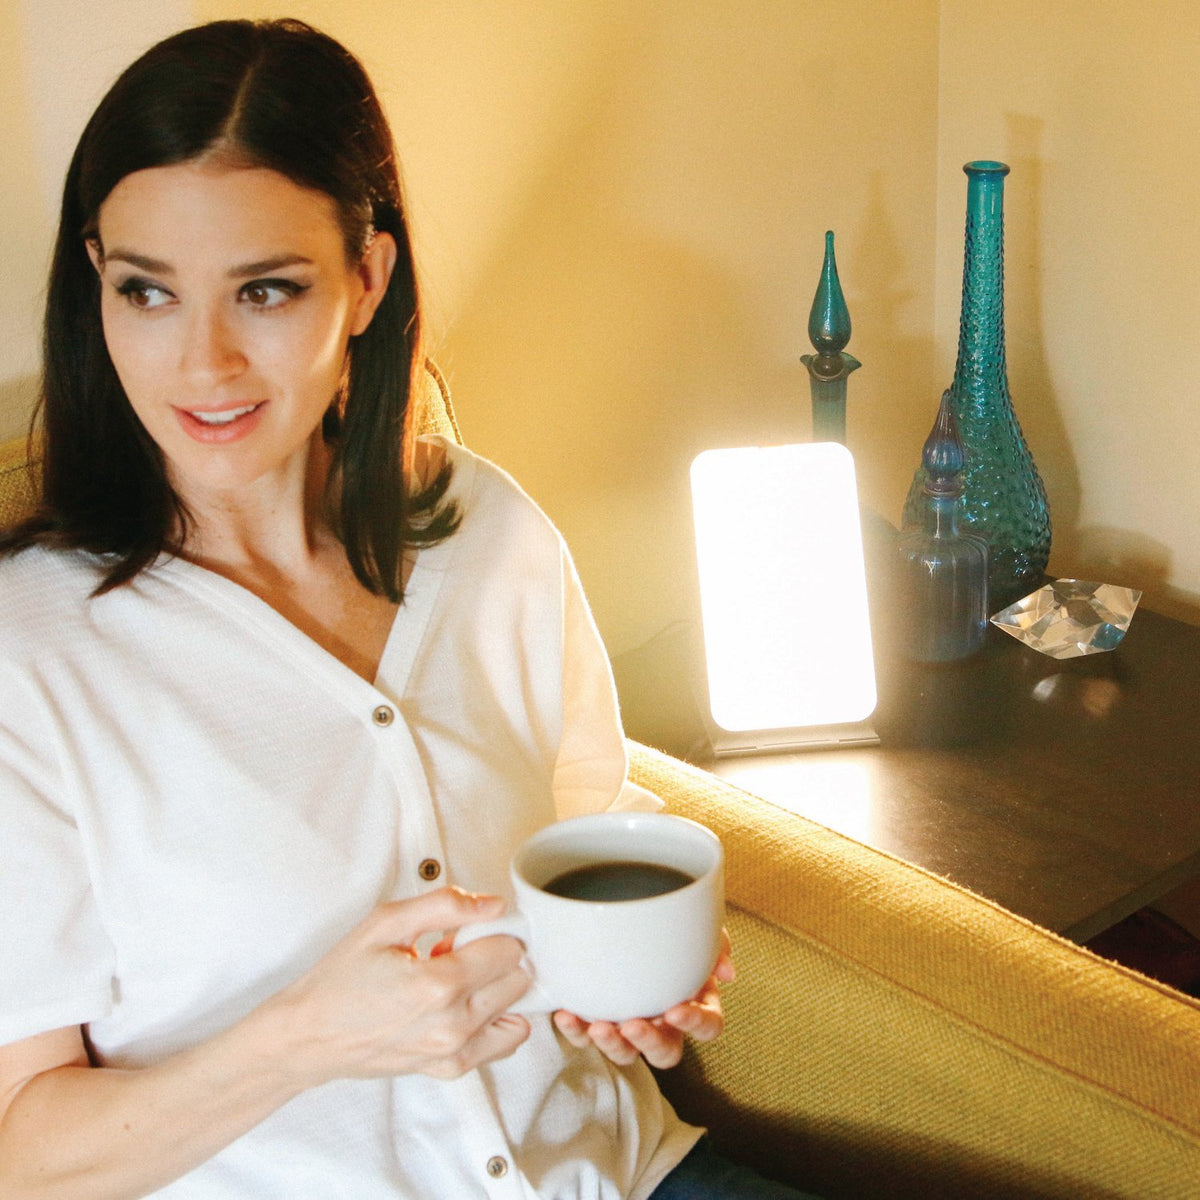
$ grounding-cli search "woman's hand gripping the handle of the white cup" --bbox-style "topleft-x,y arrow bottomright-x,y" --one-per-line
272,888 -> 529,1086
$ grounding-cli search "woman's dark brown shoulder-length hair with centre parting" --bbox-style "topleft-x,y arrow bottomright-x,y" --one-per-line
0,20 -> 458,602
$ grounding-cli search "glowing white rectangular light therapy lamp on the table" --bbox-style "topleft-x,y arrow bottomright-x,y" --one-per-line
691,442 -> 877,752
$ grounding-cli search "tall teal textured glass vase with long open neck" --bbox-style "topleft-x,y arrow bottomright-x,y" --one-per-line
904,162 -> 1050,612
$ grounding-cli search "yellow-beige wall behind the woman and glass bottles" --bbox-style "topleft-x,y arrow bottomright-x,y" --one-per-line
0,0 -> 1200,667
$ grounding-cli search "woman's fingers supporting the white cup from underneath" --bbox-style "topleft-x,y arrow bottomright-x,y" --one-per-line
554,930 -> 734,1068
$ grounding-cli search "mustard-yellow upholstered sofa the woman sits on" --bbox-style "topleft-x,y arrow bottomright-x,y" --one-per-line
0,374 -> 1200,1200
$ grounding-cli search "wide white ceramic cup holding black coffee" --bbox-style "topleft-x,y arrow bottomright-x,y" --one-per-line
455,812 -> 725,1021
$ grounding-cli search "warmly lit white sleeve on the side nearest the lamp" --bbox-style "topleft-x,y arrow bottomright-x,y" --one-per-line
554,546 -> 662,818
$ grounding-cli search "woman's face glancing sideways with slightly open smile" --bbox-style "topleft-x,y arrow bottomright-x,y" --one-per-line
89,162 -> 395,502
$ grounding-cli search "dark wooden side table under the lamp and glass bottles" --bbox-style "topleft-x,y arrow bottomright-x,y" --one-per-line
703,610 -> 1200,942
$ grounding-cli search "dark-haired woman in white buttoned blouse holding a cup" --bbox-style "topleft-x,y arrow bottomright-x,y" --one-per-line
0,22 -> 816,1200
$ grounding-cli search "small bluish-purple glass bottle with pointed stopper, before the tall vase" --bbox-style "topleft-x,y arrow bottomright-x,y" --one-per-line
896,391 -> 988,662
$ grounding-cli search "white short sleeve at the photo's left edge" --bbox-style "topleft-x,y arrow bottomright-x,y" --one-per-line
0,680 -> 114,1044
